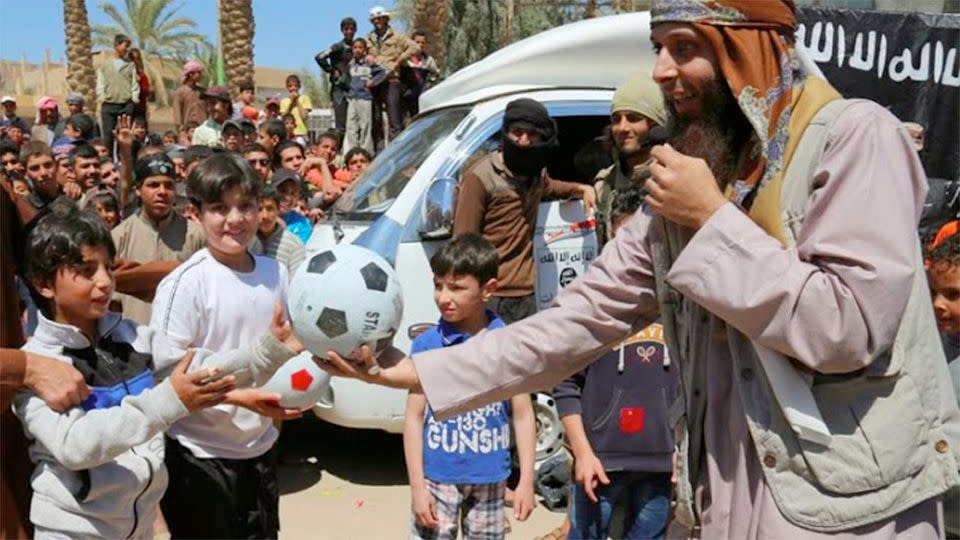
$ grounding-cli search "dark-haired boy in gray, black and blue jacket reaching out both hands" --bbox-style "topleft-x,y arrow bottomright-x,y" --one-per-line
14,202 -> 302,539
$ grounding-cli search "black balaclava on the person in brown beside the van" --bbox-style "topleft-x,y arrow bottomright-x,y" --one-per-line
500,98 -> 557,179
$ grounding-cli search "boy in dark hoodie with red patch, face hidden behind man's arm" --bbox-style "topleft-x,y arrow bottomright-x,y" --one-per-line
553,189 -> 678,539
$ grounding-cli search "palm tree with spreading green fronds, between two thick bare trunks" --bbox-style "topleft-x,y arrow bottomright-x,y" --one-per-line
93,0 -> 209,104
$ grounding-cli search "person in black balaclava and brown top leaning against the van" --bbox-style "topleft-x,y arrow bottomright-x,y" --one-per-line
453,98 -> 596,324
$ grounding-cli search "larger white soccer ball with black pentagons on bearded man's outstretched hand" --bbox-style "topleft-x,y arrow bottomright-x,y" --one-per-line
287,244 -> 403,358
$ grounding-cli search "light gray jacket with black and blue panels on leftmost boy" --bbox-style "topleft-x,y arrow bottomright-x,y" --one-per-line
14,314 -> 293,538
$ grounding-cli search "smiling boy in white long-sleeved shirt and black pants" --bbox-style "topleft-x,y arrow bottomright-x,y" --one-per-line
150,153 -> 289,538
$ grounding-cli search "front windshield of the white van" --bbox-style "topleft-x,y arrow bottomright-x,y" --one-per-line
334,108 -> 469,221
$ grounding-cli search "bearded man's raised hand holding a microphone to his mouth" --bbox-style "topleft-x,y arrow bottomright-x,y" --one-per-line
644,144 -> 727,229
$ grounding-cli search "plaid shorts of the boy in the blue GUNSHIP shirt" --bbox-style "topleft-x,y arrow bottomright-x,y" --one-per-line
410,478 -> 507,540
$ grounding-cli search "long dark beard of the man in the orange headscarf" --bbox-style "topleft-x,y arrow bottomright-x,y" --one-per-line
668,79 -> 753,187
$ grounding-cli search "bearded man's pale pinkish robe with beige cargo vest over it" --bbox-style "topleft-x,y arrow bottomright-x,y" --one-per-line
415,102 -> 960,537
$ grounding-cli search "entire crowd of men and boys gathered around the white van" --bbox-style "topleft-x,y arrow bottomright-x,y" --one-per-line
0,0 -> 960,539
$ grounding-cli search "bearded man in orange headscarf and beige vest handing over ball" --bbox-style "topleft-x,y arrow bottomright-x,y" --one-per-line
327,0 -> 960,539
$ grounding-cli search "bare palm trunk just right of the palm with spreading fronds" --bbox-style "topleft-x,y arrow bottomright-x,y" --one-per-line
219,0 -> 254,97
